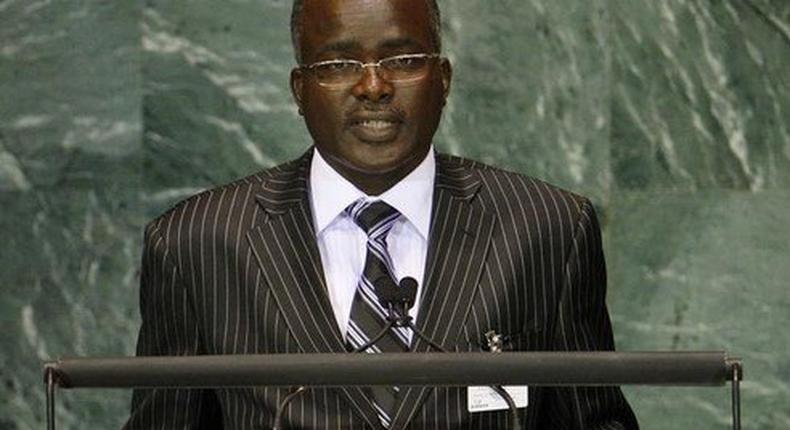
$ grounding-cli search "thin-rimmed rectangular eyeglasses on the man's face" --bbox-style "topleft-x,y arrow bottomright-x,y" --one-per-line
300,54 -> 439,87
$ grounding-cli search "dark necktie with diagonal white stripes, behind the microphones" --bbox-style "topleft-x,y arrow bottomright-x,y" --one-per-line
346,199 -> 409,427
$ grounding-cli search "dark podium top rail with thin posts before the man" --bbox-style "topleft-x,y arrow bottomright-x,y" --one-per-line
44,351 -> 743,430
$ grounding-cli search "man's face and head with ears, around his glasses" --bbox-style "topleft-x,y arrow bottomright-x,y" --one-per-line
291,0 -> 452,194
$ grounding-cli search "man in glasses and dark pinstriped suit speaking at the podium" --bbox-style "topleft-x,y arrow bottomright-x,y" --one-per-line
127,0 -> 637,429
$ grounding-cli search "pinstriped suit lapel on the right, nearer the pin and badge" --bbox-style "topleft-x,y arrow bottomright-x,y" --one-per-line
392,155 -> 496,429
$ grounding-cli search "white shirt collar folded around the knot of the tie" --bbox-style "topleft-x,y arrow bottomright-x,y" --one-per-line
310,146 -> 436,240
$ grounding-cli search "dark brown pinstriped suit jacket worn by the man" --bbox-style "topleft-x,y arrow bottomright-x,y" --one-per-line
126,150 -> 637,430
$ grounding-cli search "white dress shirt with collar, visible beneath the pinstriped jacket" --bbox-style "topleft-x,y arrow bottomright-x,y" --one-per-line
310,147 -> 436,339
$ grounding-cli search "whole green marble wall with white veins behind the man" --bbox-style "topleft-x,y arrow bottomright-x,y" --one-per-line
0,0 -> 790,430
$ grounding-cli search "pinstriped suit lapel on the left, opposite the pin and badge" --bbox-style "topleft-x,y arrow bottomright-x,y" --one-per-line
247,151 -> 381,428
